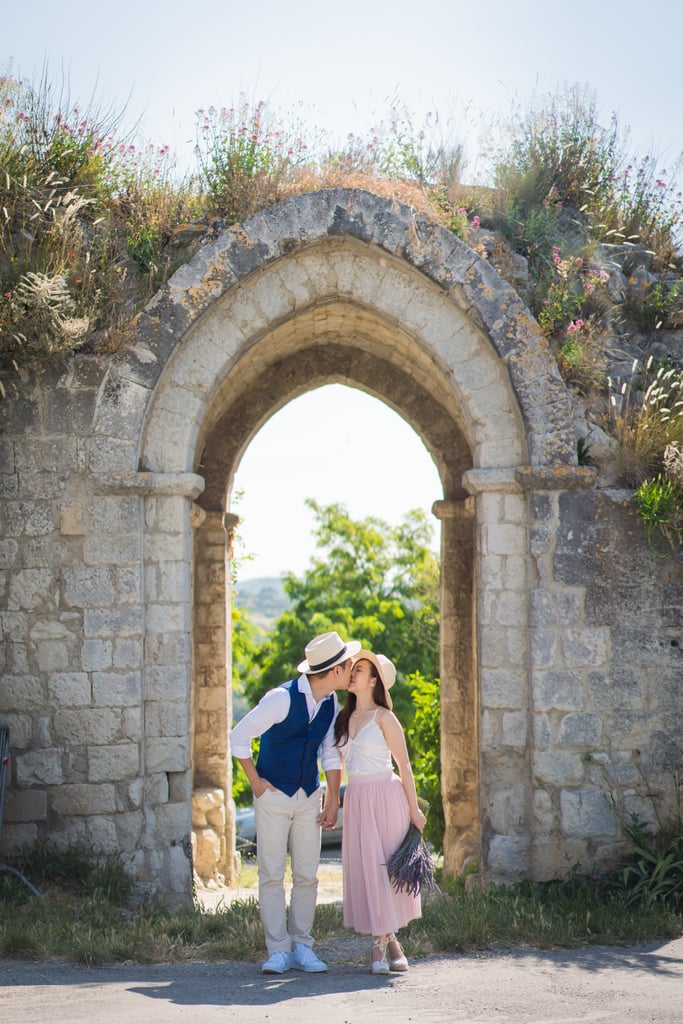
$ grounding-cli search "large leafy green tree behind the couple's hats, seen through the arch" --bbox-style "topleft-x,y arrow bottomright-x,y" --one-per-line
247,499 -> 439,726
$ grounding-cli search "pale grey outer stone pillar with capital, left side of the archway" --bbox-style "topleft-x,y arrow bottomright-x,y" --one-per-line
97,472 -> 204,906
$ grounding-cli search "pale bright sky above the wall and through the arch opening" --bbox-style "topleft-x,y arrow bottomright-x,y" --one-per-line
6,0 -> 683,578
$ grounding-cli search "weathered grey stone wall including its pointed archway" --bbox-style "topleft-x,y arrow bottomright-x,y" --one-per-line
0,191 -> 683,901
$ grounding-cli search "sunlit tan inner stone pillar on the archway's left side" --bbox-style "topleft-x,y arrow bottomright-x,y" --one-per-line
193,510 -> 239,885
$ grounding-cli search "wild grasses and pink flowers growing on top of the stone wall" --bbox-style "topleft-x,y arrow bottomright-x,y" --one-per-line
0,74 -> 683,547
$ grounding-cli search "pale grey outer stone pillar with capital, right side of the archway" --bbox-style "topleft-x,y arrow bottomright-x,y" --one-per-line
463,465 -> 595,882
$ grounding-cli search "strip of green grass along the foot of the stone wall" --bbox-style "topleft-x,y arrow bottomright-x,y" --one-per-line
0,839 -> 683,964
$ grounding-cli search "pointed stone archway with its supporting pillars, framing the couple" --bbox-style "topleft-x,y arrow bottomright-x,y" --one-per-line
101,190 -> 575,897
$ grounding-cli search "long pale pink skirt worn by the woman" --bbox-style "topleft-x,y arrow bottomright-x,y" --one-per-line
342,772 -> 422,935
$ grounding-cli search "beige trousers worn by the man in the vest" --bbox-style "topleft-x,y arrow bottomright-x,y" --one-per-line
254,788 -> 321,955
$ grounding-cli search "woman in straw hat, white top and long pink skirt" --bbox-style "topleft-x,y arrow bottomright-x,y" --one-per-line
335,650 -> 426,974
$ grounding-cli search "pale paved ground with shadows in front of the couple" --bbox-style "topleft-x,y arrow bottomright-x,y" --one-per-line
0,939 -> 683,1024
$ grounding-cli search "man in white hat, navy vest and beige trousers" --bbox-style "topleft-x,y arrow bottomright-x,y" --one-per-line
230,632 -> 360,974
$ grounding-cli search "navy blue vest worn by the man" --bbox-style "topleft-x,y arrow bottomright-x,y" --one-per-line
256,679 -> 335,797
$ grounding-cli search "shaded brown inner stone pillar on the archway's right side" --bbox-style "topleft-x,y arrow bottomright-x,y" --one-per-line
432,498 -> 479,878
